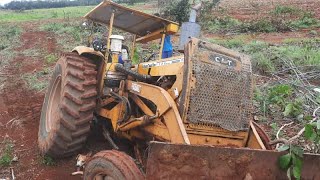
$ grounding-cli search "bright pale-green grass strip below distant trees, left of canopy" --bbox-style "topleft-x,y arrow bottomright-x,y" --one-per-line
0,6 -> 95,22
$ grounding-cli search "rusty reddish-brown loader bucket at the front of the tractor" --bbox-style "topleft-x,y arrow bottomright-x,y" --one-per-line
146,142 -> 320,180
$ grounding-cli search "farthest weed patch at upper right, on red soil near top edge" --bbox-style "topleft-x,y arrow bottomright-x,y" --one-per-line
200,6 -> 320,33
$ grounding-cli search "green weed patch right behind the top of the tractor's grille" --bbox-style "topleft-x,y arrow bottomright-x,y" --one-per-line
209,39 -> 320,75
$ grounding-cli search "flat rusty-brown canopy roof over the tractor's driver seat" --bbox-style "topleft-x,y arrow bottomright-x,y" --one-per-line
85,1 -> 178,36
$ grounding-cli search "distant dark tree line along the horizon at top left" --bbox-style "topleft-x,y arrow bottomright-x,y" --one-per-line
0,0 -> 146,10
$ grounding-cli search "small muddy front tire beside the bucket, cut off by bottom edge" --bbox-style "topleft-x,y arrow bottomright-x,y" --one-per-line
83,150 -> 145,180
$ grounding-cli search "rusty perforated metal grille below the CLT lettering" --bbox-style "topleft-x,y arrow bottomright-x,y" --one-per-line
187,58 -> 252,131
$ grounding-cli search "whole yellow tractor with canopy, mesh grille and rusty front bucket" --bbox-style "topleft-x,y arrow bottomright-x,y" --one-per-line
38,1 -> 320,179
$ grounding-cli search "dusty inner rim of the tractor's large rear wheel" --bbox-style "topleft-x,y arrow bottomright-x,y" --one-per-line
46,75 -> 61,132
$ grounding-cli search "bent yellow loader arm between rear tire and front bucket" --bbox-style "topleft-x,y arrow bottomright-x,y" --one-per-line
97,80 -> 190,144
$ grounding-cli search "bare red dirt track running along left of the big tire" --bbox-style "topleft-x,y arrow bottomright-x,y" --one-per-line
0,23 -> 79,179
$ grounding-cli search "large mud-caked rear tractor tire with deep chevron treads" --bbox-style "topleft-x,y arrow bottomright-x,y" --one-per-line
38,53 -> 97,157
